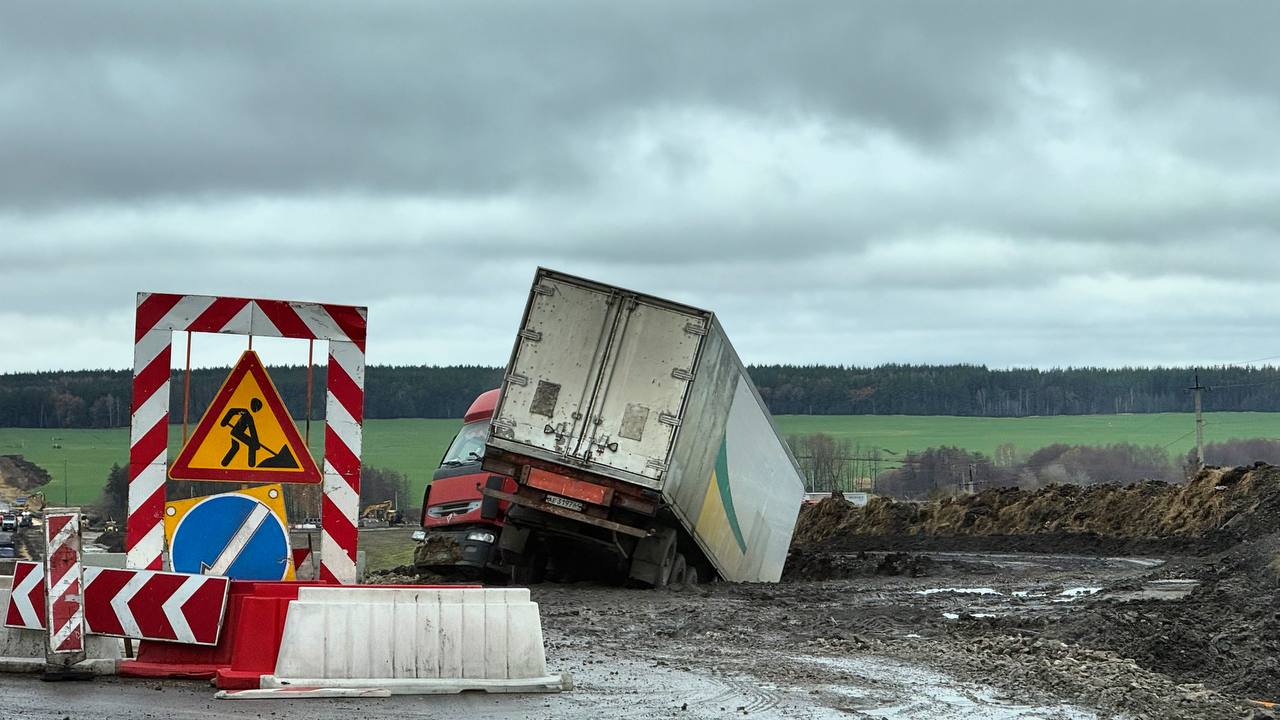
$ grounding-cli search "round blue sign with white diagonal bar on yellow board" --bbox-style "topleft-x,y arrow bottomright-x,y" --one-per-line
164,484 -> 294,580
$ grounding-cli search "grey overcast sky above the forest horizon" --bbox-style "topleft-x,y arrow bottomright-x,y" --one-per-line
0,0 -> 1280,372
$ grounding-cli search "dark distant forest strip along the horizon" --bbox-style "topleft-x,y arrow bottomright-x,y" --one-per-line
0,365 -> 1280,428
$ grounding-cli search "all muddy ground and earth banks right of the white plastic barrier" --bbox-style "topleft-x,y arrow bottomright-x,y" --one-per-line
381,465 -> 1280,719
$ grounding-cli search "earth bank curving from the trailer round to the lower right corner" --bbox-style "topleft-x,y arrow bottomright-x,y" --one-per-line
787,464 -> 1280,702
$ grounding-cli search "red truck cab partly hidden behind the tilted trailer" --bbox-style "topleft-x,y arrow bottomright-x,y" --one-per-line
413,389 -> 516,574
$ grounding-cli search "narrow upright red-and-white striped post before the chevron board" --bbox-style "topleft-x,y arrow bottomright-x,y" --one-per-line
45,511 -> 84,653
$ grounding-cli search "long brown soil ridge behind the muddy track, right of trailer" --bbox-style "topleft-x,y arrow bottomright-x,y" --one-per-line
792,464 -> 1280,553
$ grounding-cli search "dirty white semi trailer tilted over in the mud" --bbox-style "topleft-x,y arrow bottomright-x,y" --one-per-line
483,268 -> 804,587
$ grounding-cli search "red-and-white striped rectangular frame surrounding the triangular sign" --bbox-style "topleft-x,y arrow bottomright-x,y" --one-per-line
124,292 -> 367,584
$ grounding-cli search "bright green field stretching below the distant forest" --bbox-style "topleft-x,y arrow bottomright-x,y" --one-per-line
0,413 -> 1280,506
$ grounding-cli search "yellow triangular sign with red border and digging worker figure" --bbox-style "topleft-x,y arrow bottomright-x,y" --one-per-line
169,350 -> 320,483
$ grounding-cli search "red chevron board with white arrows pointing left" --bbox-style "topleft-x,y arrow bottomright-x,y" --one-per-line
5,561 -> 230,646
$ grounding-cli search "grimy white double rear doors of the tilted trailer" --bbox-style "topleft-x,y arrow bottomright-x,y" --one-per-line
490,270 -> 710,488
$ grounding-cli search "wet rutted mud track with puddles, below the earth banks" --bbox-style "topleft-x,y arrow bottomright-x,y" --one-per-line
517,545 -> 1267,719
